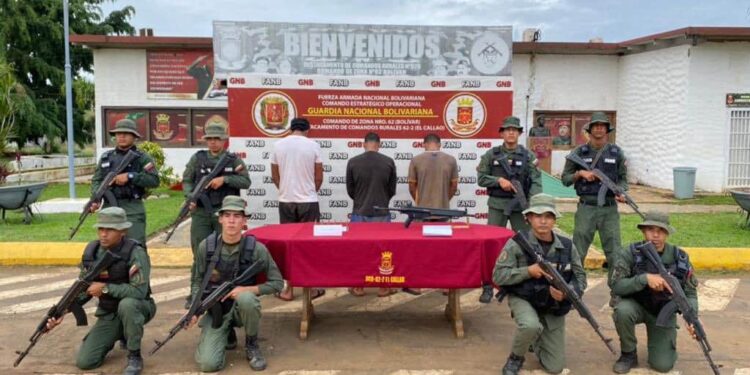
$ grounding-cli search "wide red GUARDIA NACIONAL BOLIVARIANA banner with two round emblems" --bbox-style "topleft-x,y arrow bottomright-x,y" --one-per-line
229,88 -> 513,139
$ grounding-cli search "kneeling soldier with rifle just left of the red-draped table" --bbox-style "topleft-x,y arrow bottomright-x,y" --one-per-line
190,195 -> 284,372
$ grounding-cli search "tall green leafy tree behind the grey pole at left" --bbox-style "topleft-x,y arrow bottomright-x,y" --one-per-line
0,0 -> 135,150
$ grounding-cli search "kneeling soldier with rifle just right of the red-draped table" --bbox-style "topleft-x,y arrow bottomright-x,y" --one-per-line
492,194 -> 586,375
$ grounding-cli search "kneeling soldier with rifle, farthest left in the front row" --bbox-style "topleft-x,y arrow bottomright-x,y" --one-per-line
47,207 -> 156,375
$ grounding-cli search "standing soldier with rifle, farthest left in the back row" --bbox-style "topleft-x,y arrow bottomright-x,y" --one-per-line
91,119 -> 159,246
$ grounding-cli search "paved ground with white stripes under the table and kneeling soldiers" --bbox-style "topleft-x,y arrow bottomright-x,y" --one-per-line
0,267 -> 750,375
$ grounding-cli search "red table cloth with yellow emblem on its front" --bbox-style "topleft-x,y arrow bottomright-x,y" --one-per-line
248,223 -> 513,289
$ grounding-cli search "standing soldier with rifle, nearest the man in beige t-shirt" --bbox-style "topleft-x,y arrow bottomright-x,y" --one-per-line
477,116 -> 542,303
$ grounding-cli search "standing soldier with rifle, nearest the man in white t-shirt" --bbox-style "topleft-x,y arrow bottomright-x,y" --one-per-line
182,123 -> 250,309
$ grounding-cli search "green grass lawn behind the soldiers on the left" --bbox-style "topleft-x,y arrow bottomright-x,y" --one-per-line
0,184 -> 184,242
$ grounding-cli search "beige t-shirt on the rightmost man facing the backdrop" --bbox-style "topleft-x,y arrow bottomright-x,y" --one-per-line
409,151 -> 458,208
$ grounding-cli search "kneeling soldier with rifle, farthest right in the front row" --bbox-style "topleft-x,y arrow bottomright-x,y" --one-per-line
609,212 -> 698,374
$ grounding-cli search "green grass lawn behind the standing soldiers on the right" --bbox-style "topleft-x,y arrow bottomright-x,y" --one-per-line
557,213 -> 750,249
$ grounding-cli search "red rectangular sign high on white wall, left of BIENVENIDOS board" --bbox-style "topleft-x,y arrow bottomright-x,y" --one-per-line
146,49 -> 214,99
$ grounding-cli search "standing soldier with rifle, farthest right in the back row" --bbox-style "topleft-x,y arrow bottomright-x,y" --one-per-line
562,112 -> 628,264
